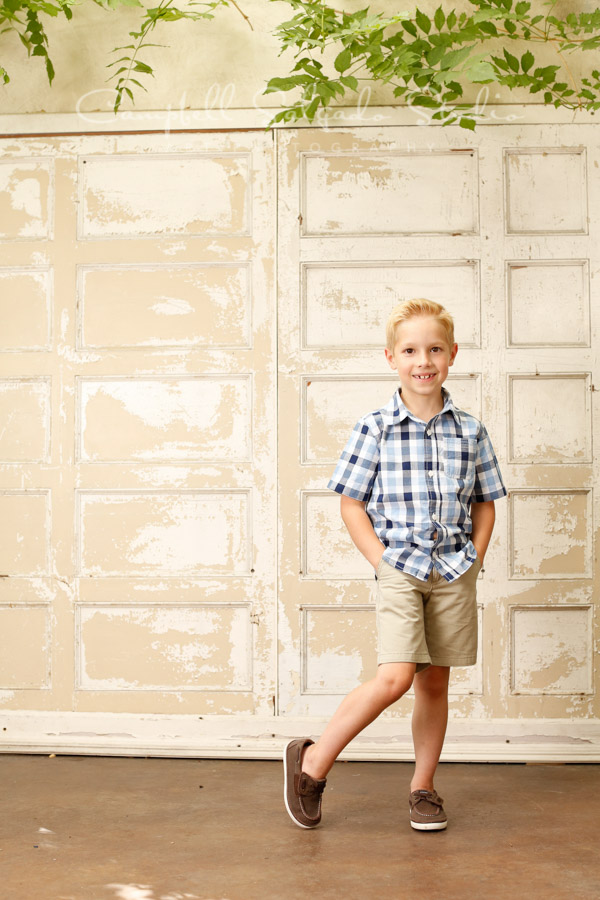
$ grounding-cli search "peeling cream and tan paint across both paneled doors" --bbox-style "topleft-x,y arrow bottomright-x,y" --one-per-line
0,126 -> 600,740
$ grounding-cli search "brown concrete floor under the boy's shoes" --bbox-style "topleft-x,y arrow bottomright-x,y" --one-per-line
0,755 -> 600,900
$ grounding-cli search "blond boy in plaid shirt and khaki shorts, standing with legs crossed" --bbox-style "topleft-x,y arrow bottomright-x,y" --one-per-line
284,299 -> 506,831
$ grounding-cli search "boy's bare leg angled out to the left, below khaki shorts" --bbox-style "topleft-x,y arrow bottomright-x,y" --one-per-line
302,663 -> 416,778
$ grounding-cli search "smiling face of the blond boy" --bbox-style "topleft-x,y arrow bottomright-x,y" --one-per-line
385,316 -> 458,403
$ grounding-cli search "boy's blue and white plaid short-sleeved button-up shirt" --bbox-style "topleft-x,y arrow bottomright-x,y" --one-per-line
327,388 -> 506,581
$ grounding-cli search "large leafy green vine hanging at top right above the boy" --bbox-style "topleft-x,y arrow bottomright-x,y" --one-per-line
265,0 -> 600,129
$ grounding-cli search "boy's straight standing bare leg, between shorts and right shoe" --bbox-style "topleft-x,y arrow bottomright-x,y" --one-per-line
410,666 -> 450,791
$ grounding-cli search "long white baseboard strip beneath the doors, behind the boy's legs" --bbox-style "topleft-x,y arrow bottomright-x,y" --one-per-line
0,711 -> 600,763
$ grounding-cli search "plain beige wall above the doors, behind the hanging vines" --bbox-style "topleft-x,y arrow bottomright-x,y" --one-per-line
0,0 -> 596,116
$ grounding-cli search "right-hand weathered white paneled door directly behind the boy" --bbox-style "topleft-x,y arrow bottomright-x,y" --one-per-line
279,126 -> 600,759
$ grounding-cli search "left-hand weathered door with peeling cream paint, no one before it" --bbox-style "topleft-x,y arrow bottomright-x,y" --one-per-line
0,129 -> 276,753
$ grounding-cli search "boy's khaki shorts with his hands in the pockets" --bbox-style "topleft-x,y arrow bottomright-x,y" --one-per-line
377,559 -> 481,672
